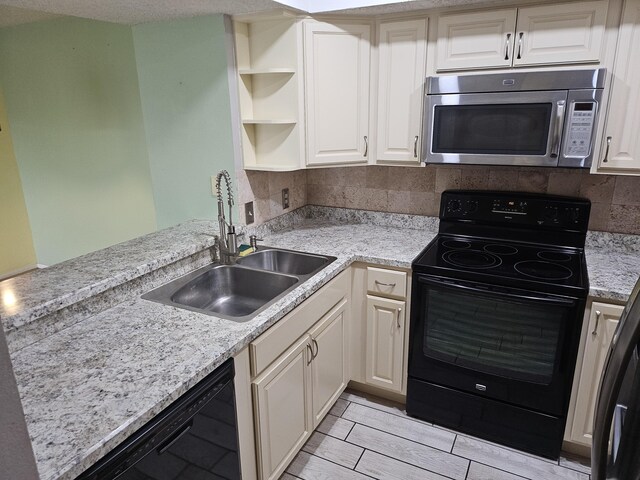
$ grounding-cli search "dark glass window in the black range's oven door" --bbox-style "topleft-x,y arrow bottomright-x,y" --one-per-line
422,286 -> 567,384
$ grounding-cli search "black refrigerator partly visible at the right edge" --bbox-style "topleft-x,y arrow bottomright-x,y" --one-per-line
591,279 -> 640,480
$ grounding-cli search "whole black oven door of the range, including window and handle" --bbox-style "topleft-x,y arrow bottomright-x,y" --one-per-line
409,274 -> 584,415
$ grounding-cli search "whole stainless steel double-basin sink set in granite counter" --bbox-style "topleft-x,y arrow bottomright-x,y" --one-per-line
142,247 -> 336,322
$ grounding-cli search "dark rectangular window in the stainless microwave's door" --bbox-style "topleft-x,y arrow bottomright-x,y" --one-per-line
432,103 -> 553,155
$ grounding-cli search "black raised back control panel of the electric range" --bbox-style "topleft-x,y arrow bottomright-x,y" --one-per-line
440,190 -> 591,232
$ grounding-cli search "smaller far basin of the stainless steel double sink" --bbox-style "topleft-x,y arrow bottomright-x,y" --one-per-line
238,248 -> 335,275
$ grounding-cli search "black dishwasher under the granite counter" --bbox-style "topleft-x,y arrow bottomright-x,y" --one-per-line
78,359 -> 240,480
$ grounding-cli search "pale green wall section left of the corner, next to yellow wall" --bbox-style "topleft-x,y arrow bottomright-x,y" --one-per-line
0,18 -> 156,265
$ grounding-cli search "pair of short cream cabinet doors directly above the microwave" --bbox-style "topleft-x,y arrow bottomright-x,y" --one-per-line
436,0 -> 608,71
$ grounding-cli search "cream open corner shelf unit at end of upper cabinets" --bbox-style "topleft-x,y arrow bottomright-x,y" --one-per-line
234,17 -> 305,171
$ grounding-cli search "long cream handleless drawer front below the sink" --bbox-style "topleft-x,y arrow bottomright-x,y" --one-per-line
249,272 -> 349,377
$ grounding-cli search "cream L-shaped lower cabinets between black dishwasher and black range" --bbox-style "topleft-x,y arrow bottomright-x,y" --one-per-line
249,265 -> 410,480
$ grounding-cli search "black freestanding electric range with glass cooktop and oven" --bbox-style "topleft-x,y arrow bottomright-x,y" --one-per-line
407,190 -> 590,458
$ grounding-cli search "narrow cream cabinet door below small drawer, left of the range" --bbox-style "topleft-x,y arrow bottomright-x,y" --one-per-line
365,295 -> 406,392
